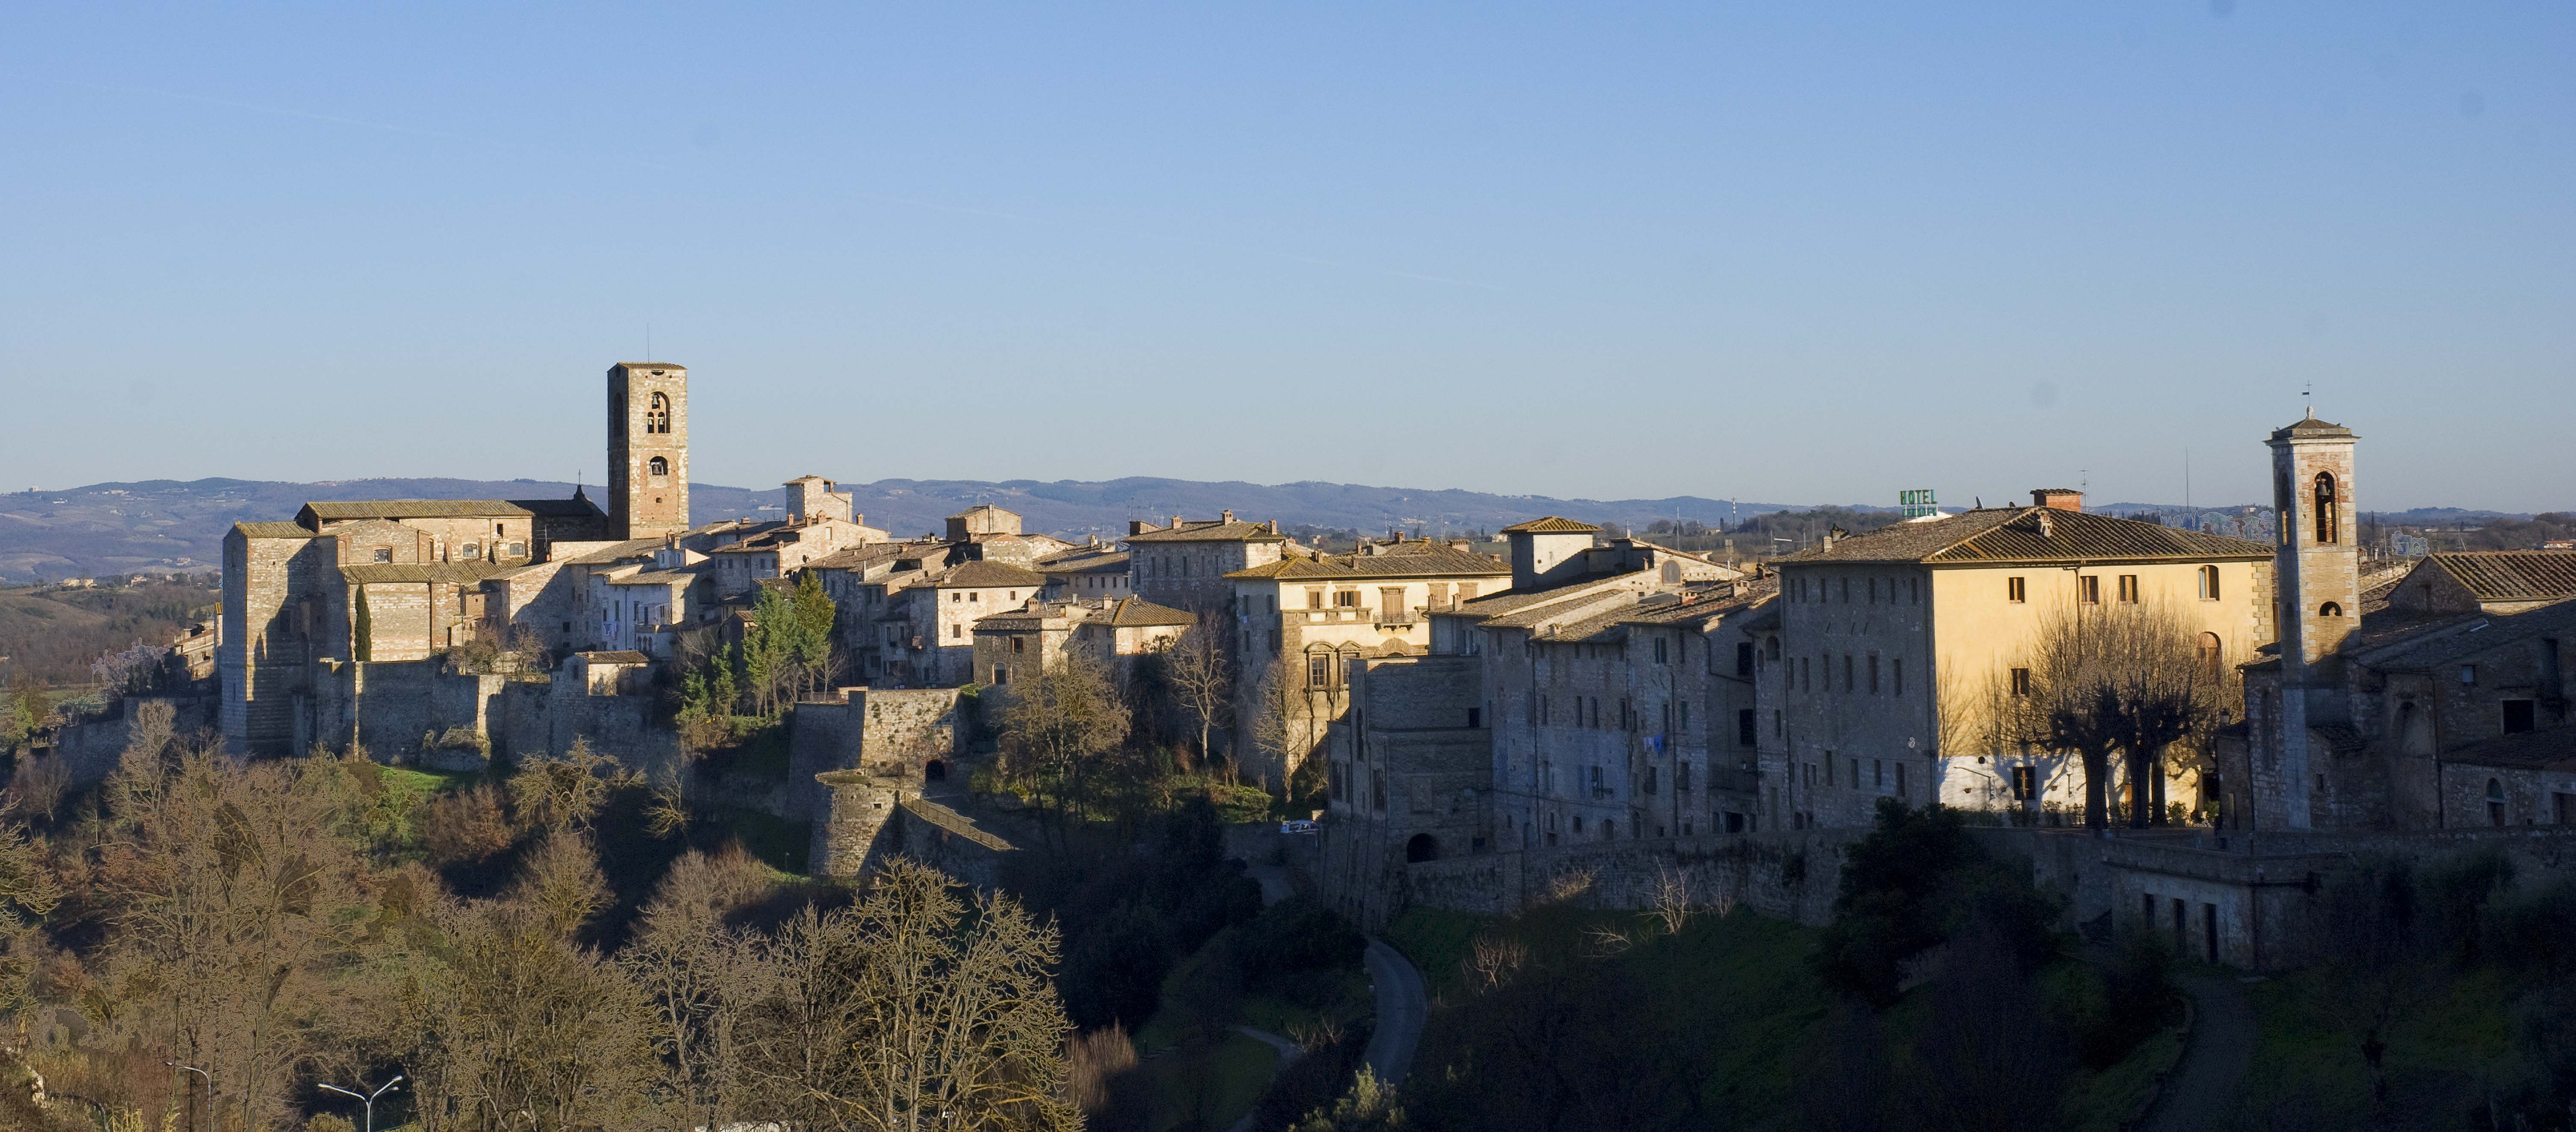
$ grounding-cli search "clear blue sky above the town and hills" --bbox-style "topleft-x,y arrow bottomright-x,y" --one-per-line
0,0 -> 2576,510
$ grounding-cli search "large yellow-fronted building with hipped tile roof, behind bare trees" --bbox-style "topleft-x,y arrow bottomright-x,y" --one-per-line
1754,490 -> 2272,825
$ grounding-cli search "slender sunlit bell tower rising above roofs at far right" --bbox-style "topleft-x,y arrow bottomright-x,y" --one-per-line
2267,412 -> 2362,681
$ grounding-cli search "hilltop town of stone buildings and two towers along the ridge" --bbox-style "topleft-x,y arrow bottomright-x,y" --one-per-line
13,361 -> 2576,1119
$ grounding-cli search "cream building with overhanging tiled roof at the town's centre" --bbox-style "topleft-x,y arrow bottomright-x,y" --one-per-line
1218,536 -> 1512,781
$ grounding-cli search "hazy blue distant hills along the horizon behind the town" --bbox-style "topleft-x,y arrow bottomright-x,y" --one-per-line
0,477 -> 1824,580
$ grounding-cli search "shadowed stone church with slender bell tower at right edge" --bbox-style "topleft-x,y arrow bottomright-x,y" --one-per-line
2221,415 -> 2576,830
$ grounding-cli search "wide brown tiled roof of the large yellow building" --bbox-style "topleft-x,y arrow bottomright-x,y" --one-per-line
1780,508 -> 2272,565
